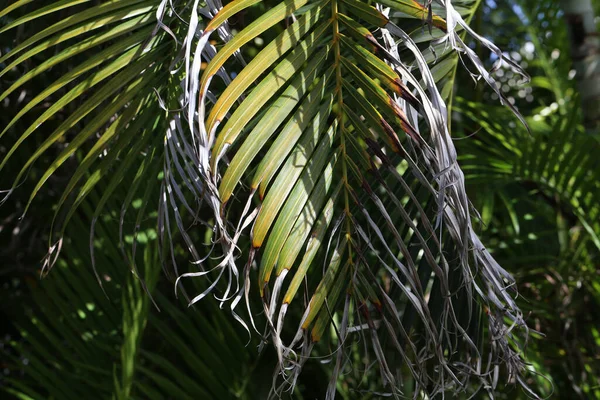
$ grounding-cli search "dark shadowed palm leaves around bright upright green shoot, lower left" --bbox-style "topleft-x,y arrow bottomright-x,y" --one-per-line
2,191 -> 260,399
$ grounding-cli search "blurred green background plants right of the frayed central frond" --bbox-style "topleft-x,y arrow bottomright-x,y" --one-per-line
453,1 -> 600,399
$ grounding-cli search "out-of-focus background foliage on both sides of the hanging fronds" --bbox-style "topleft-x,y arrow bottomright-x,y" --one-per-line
0,0 -> 600,399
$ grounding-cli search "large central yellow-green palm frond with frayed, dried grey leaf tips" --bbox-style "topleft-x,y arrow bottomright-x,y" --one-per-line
163,0 -> 523,396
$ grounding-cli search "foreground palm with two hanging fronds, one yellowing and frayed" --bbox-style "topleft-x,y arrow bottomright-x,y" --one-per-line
0,0 -> 533,398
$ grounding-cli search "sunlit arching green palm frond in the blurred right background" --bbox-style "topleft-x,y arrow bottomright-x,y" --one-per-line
456,98 -> 600,251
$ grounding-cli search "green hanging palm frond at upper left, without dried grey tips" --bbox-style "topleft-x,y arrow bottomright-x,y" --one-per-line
0,1 -> 172,272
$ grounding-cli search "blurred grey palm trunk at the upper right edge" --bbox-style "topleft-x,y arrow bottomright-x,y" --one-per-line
562,0 -> 600,134
